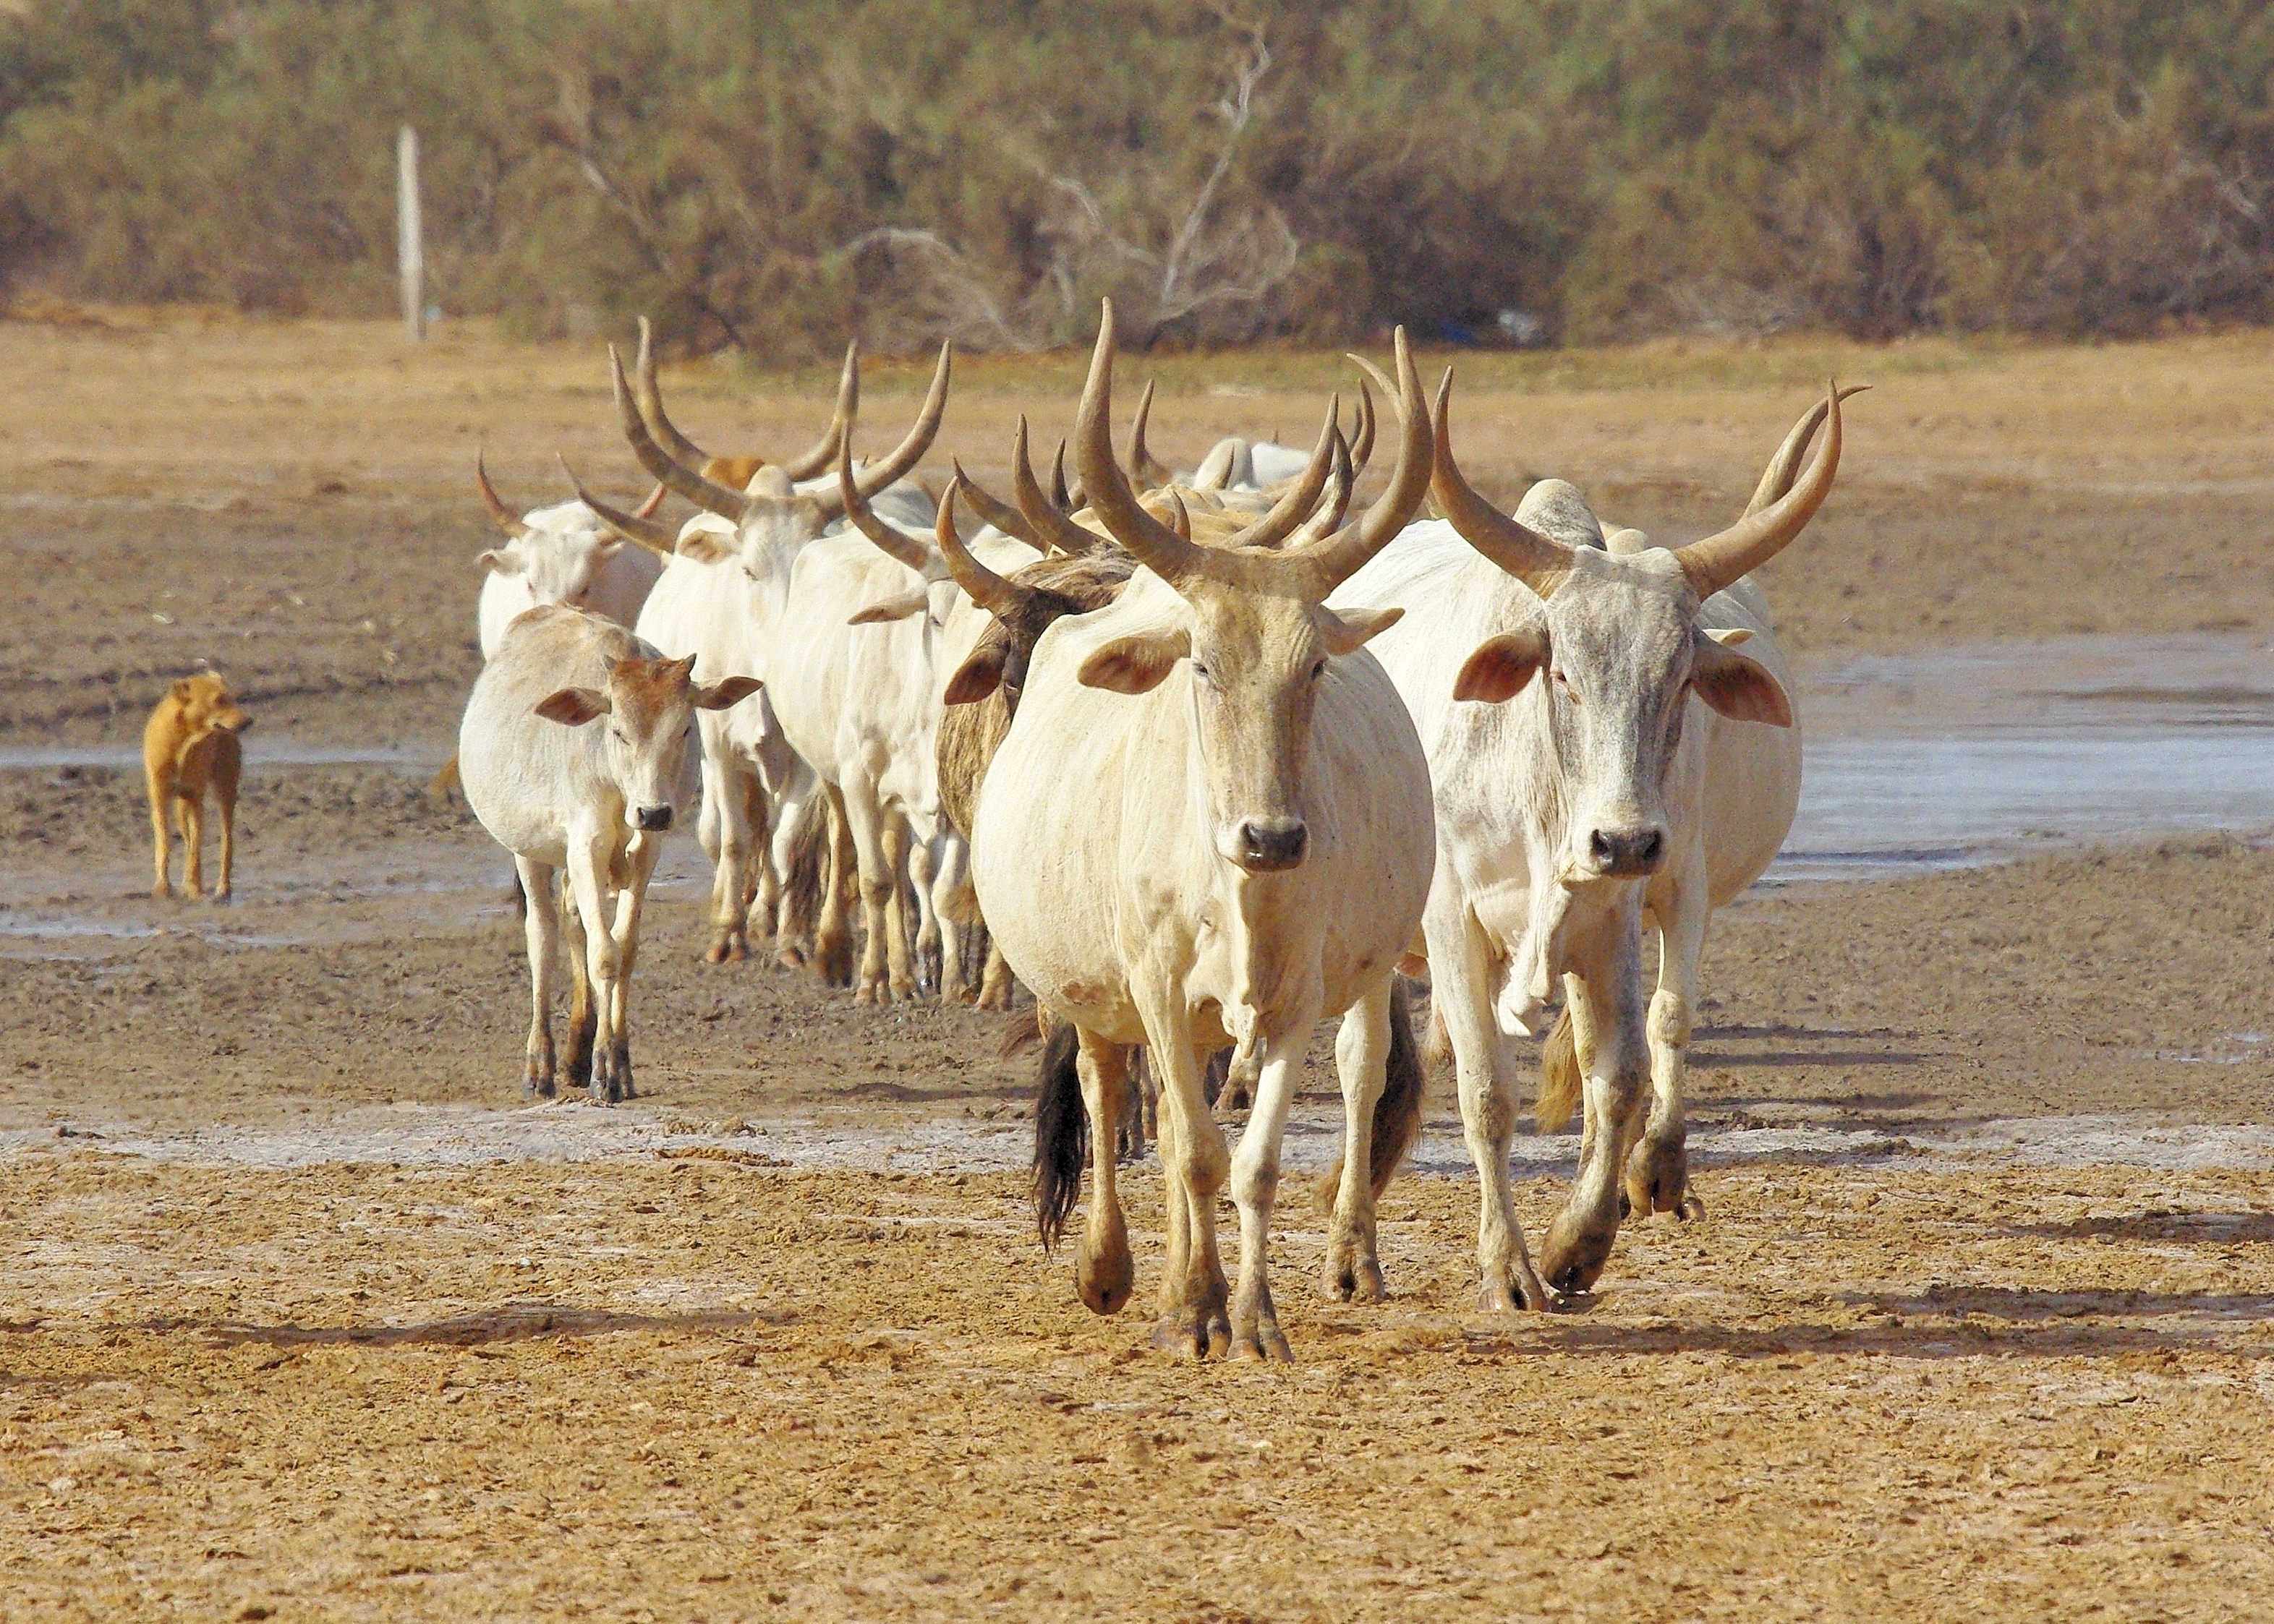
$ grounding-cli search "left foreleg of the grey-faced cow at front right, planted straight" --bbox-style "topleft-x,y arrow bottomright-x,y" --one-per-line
1428,896 -> 1549,1312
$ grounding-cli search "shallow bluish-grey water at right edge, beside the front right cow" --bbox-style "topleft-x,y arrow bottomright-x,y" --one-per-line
1769,637 -> 2274,883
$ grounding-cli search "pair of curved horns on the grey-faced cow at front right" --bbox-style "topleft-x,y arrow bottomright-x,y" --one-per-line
1431,369 -> 1856,598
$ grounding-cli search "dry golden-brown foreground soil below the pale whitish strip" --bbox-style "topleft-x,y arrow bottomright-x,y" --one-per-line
0,1142 -> 2274,1620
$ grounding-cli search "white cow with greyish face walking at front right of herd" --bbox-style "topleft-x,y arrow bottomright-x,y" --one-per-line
1332,373 -> 1839,1310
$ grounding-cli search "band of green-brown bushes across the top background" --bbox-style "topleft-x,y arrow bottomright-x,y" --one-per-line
0,0 -> 2274,357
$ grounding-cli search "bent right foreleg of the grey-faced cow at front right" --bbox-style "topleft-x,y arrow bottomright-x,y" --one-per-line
1539,887 -> 1651,1292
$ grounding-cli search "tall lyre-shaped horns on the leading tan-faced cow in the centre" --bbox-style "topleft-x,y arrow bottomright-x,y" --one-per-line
1073,300 -> 1433,603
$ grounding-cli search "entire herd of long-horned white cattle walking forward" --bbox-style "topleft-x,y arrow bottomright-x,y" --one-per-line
459,307 -> 1851,1358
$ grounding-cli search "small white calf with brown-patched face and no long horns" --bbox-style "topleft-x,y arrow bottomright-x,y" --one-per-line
457,605 -> 757,1101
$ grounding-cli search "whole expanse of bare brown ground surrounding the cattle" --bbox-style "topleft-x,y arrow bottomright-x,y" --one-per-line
0,318 -> 2274,1620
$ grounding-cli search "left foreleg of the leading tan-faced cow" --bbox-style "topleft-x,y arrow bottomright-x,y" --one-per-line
1139,989 -> 1232,1358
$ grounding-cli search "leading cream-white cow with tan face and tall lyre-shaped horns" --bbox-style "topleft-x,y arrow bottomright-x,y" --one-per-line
971,305 -> 1433,1358
